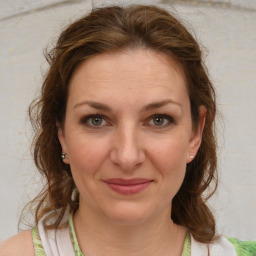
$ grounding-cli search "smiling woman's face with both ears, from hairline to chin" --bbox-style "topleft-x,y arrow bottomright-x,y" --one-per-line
58,49 -> 204,223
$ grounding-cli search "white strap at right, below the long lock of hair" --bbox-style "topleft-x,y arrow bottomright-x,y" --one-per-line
191,236 -> 236,256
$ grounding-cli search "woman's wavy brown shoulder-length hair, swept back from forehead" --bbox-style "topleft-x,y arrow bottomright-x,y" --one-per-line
25,5 -> 217,243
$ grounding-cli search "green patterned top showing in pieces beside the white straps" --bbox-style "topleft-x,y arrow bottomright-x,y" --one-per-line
32,215 -> 256,256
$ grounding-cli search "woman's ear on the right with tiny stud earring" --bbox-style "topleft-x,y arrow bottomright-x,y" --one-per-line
187,106 -> 206,163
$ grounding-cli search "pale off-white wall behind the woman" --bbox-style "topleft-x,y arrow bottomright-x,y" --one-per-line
0,0 -> 256,241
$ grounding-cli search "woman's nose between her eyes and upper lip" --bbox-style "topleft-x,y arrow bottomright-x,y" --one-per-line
110,125 -> 145,171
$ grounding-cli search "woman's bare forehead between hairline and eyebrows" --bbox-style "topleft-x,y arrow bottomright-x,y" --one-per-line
70,49 -> 187,106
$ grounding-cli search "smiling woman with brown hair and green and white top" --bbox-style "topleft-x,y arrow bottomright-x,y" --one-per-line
0,6 -> 256,256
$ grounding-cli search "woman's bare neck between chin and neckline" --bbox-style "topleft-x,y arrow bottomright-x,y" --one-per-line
74,207 -> 186,256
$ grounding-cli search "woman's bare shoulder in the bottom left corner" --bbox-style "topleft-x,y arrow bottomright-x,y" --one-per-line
0,230 -> 35,256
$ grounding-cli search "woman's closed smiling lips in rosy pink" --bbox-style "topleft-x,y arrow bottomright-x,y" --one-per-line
103,178 -> 153,195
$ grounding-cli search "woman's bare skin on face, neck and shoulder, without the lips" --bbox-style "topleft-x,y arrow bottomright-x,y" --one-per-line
0,49 -> 206,256
